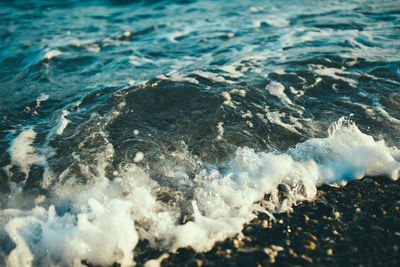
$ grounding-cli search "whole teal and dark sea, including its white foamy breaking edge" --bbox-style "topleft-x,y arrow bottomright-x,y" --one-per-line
0,0 -> 400,266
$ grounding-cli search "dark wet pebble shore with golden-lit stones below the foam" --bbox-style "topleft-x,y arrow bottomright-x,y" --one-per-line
135,178 -> 400,266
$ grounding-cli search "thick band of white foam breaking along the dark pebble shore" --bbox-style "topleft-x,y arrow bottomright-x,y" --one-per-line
0,119 -> 400,266
